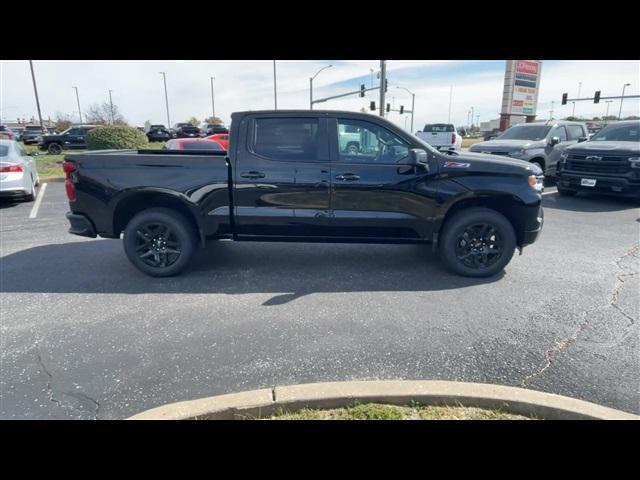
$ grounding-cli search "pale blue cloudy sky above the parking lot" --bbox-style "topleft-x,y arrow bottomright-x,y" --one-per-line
0,60 -> 640,131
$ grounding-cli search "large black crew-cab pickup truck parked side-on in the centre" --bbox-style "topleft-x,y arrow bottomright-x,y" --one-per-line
63,110 -> 543,277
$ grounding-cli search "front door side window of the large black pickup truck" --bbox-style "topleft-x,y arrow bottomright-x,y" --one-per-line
338,119 -> 409,164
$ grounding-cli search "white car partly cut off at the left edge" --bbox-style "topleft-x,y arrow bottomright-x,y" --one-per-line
0,139 -> 40,201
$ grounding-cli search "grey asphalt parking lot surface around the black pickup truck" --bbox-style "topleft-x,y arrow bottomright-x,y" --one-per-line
0,182 -> 640,419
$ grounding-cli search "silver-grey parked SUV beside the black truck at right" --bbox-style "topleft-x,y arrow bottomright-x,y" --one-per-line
469,120 -> 589,177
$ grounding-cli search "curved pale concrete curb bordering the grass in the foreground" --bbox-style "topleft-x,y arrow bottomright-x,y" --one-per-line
129,380 -> 640,420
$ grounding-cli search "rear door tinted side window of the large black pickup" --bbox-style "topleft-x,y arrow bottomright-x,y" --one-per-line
252,118 -> 319,161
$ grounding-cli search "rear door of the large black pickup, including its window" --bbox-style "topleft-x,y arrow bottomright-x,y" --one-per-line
234,114 -> 330,237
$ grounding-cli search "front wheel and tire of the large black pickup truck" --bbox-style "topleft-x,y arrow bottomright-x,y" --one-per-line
438,207 -> 516,277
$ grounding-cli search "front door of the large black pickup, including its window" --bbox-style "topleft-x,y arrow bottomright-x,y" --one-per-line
329,118 -> 437,240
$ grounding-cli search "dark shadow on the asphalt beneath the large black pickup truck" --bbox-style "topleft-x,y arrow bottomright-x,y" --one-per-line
0,240 -> 504,306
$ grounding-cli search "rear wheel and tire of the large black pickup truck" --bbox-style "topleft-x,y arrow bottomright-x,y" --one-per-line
123,208 -> 196,277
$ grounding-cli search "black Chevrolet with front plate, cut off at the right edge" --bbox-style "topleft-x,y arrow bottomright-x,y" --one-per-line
556,120 -> 640,199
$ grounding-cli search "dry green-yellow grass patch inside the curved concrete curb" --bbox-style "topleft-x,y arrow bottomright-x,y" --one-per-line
266,403 -> 530,420
